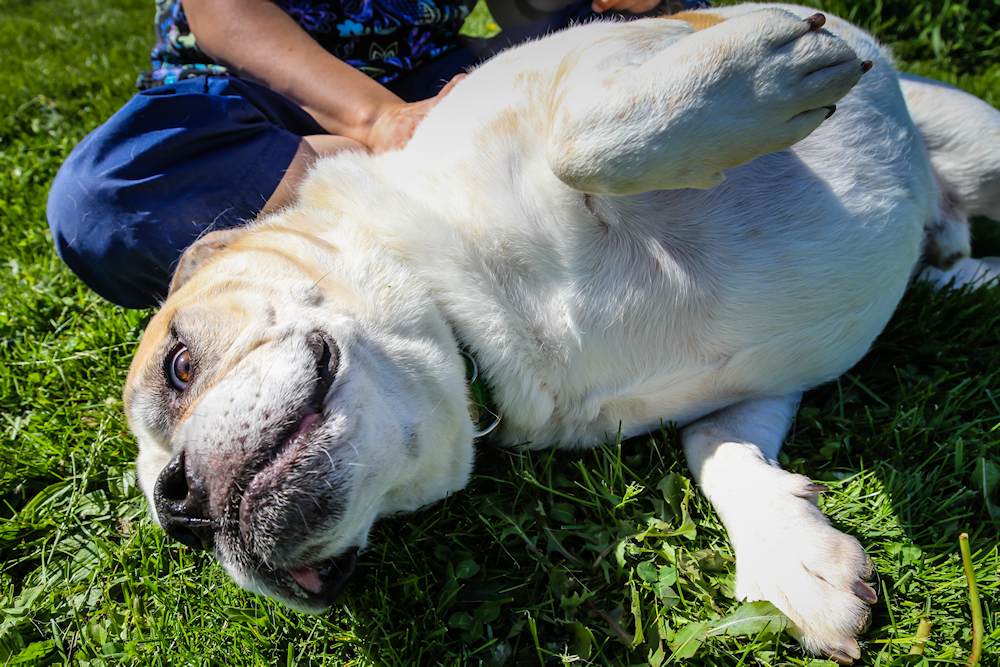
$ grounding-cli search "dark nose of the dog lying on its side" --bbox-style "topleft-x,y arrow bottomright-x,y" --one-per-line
153,452 -> 215,550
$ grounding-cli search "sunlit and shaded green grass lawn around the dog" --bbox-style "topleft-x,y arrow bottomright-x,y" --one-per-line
0,0 -> 1000,667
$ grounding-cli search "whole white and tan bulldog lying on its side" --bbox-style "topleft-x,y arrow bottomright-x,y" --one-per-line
125,5 -> 1000,663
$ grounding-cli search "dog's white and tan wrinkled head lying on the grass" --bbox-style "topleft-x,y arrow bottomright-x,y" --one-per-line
125,220 -> 472,612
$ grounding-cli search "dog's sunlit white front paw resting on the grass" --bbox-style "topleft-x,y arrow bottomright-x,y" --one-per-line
731,470 -> 878,664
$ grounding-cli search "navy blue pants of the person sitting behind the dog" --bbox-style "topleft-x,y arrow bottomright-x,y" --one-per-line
46,0 -> 707,308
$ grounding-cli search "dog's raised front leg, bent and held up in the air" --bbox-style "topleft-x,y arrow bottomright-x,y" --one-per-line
547,9 -> 871,195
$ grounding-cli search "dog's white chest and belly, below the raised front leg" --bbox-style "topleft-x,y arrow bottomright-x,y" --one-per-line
302,9 -> 933,446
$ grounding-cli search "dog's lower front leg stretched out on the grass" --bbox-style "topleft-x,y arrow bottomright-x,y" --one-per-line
681,394 -> 877,664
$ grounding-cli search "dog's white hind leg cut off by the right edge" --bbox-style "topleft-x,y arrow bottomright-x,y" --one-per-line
899,74 -> 1000,270
